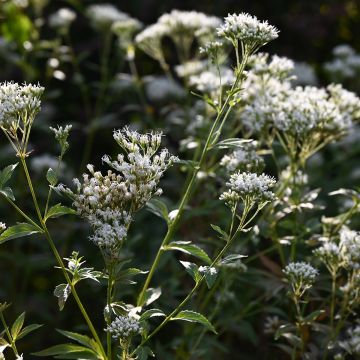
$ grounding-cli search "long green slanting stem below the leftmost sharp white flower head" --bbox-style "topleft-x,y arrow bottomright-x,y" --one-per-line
20,156 -> 106,359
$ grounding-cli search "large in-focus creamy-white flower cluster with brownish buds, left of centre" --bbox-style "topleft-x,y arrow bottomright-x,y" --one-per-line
59,128 -> 177,251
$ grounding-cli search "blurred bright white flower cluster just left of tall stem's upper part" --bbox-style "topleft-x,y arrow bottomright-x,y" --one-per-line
189,68 -> 235,93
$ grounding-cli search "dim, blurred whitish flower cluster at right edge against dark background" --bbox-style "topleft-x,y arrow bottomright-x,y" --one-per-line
324,44 -> 360,82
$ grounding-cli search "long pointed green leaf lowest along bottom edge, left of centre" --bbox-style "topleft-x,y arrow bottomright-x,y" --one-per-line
33,344 -> 100,360
